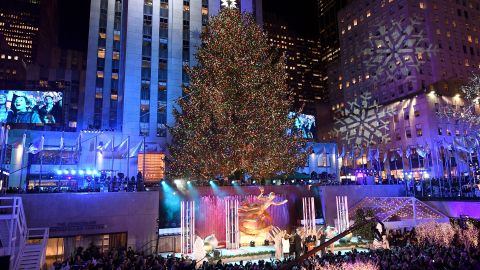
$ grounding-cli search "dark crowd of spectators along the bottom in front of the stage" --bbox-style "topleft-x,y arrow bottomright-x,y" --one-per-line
51,226 -> 480,270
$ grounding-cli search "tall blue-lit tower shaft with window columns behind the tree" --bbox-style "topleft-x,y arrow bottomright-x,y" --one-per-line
83,0 -> 262,149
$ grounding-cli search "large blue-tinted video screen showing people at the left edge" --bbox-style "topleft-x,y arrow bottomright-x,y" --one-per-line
0,90 -> 63,125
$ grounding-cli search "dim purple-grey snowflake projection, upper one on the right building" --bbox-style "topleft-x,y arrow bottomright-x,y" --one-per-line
363,18 -> 435,81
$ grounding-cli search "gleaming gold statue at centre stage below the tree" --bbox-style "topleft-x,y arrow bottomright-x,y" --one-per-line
238,187 -> 288,237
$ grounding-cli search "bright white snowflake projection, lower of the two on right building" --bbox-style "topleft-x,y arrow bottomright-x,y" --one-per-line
333,92 -> 393,146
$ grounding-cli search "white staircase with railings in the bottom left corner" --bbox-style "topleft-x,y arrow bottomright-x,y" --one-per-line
0,197 -> 49,270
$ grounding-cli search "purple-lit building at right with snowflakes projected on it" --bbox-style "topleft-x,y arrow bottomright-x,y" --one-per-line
329,0 -> 480,179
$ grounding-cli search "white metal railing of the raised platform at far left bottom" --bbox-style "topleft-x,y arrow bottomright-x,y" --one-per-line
0,197 -> 28,269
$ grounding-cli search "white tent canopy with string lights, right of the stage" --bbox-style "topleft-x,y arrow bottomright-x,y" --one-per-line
349,197 -> 449,229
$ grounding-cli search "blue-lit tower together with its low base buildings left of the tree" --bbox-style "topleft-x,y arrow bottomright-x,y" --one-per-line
2,0 -> 262,188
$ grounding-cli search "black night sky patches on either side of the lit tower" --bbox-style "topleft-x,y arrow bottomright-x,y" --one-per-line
58,0 -> 318,52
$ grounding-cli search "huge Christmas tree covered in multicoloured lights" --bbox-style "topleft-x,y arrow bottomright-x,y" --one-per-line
169,7 -> 306,180
